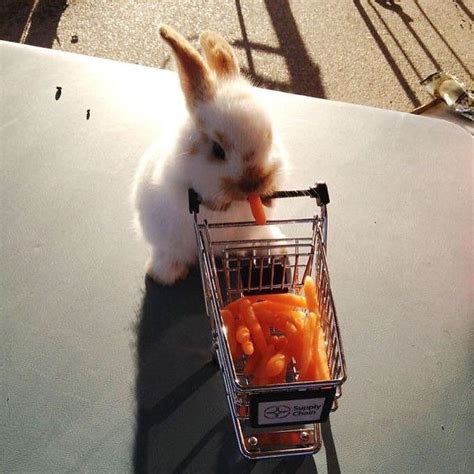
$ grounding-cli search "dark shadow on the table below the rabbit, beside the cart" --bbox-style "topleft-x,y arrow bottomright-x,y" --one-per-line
133,270 -> 328,473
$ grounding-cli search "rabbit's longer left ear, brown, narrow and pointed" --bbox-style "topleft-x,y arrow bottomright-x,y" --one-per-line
160,25 -> 215,107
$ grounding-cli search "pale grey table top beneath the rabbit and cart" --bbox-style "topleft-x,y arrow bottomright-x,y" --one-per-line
0,43 -> 474,473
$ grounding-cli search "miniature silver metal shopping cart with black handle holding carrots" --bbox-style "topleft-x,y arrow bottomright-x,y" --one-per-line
189,183 -> 346,459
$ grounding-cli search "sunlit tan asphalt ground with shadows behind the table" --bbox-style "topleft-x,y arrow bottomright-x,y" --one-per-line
0,0 -> 474,111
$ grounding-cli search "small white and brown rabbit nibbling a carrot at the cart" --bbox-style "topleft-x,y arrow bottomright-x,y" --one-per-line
132,25 -> 288,285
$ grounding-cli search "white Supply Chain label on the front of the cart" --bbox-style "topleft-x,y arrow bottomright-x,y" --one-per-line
258,398 -> 326,425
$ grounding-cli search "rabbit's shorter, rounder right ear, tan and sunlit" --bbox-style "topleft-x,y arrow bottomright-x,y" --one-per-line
199,31 -> 240,78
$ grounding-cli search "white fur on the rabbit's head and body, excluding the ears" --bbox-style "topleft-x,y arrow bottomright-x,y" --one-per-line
132,32 -> 287,284
